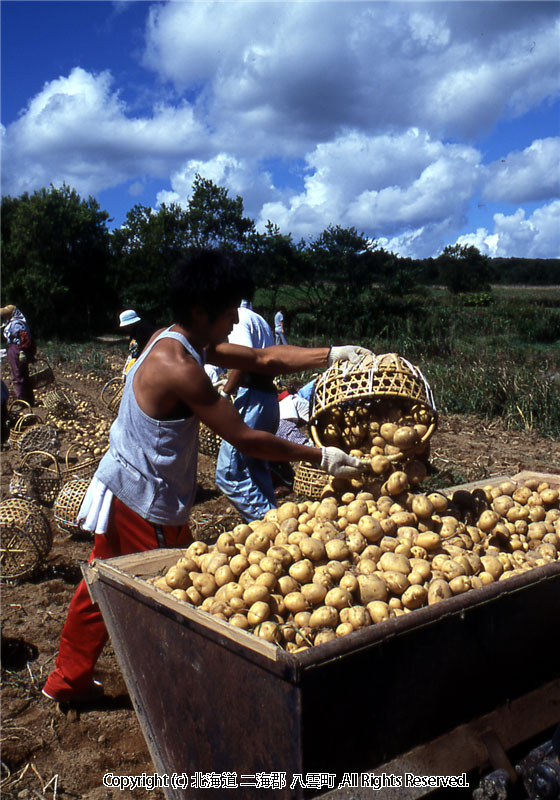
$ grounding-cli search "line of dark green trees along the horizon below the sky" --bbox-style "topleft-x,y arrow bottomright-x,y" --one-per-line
1,180 -> 560,340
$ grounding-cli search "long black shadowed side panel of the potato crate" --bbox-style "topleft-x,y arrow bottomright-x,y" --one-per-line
301,574 -> 560,773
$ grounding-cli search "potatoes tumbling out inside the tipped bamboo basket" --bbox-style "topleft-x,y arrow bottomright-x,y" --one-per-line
317,398 -> 432,496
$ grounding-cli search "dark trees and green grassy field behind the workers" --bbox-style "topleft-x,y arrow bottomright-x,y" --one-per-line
2,176 -> 560,438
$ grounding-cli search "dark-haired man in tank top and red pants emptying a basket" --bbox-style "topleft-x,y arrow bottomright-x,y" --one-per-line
43,249 -> 369,703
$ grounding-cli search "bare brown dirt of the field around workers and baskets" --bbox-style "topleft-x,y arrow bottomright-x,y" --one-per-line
0,360 -> 560,800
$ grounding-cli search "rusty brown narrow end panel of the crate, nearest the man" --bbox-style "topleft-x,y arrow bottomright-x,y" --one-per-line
96,584 -> 302,800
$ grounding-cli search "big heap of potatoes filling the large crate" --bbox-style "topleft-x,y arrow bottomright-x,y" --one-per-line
148,471 -> 560,652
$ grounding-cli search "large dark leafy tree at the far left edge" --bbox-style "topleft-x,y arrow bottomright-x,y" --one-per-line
2,185 -> 110,339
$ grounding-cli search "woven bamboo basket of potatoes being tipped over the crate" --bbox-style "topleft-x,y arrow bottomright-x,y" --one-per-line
310,353 -> 437,495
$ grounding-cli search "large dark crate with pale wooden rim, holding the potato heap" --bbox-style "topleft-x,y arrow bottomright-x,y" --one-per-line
84,476 -> 560,800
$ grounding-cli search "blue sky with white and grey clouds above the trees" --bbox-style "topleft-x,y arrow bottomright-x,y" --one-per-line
0,0 -> 560,258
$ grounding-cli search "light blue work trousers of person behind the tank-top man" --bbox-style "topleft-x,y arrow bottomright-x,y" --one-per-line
216,389 -> 280,522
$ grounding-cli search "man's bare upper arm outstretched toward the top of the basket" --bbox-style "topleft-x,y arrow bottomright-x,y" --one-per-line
206,343 -> 330,375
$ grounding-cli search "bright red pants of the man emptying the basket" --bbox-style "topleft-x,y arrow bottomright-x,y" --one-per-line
44,497 -> 192,700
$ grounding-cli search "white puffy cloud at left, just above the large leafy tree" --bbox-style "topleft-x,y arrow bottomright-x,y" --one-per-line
3,67 -> 206,194
